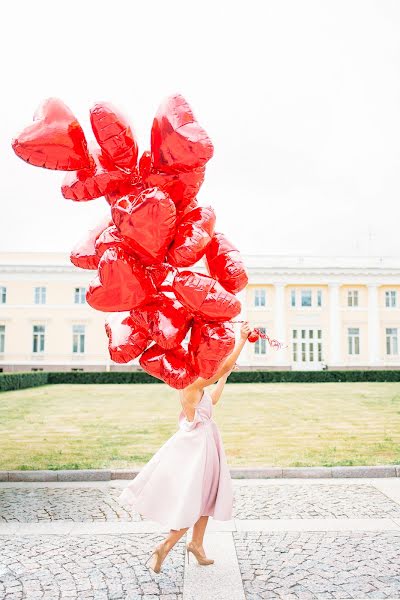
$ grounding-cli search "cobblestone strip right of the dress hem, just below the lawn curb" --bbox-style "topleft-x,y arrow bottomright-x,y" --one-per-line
235,483 -> 400,519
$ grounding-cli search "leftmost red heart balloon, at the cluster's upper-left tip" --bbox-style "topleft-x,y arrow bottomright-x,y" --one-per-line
12,98 -> 90,171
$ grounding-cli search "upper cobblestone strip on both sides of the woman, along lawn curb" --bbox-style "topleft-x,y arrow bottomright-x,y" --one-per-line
0,483 -> 400,523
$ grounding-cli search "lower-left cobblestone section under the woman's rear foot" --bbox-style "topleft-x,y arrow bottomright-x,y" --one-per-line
0,534 -> 184,600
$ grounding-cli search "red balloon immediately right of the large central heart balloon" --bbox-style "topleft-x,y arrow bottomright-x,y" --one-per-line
168,206 -> 215,267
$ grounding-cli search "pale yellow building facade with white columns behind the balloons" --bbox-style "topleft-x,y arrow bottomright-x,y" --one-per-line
0,252 -> 400,371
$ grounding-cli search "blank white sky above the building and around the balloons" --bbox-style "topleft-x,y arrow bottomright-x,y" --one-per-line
0,0 -> 400,255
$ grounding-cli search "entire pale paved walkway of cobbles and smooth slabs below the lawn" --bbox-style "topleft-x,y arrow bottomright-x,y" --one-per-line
0,477 -> 400,600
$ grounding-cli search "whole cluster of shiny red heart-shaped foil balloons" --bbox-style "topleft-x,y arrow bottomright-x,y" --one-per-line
12,95 -> 282,388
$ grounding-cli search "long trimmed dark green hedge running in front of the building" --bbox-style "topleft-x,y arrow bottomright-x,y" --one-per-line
0,370 -> 400,392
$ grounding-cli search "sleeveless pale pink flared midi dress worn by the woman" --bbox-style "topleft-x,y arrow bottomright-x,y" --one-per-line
118,390 -> 233,529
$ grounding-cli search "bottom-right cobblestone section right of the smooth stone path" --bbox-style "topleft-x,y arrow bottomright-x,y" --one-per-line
233,531 -> 400,600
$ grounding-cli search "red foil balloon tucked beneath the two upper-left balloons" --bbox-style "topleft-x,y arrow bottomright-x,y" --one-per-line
61,147 -> 126,202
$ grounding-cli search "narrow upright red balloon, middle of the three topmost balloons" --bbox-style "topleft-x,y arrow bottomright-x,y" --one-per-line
90,102 -> 138,171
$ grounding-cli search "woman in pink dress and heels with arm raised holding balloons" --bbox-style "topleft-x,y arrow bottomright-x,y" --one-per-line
119,321 -> 251,573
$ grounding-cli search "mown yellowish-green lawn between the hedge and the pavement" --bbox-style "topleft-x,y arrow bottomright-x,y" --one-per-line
0,383 -> 400,469
